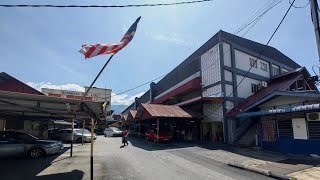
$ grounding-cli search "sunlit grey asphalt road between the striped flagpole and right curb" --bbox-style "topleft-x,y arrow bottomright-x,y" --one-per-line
94,137 -> 270,180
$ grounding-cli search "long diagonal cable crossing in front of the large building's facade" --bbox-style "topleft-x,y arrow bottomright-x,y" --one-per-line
205,0 -> 296,120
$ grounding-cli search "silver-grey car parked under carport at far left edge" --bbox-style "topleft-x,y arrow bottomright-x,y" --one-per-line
0,131 -> 64,158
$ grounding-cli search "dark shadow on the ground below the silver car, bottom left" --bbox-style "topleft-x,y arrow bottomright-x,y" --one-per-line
0,148 -> 84,180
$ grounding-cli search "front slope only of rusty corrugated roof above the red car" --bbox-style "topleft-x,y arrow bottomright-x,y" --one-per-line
141,104 -> 194,118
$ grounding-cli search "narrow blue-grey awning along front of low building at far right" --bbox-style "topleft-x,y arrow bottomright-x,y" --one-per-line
236,104 -> 320,118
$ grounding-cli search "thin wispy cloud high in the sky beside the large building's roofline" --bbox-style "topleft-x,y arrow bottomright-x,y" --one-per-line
145,32 -> 201,46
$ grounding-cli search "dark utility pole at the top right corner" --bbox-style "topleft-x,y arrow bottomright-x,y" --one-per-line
310,0 -> 320,75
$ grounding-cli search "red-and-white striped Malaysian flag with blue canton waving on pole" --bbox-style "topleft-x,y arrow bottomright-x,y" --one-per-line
79,16 -> 141,59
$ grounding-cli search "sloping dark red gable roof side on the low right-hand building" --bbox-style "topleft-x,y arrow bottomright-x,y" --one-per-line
228,68 -> 305,116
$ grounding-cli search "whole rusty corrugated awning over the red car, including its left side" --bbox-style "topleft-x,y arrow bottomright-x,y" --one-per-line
136,103 -> 197,120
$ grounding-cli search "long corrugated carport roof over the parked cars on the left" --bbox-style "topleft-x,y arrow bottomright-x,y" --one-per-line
0,91 -> 104,120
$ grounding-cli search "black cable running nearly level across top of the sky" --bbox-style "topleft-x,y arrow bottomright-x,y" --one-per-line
0,0 -> 214,8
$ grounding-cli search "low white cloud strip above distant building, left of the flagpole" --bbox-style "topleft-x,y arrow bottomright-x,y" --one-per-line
27,82 -> 84,91
